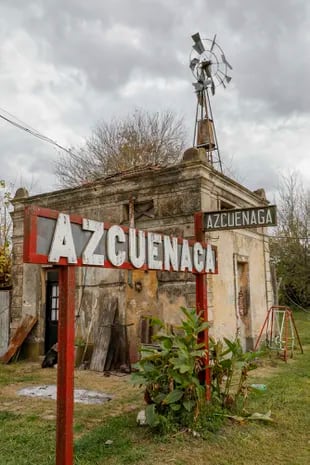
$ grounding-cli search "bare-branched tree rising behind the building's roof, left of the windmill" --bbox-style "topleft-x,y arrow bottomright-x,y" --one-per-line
55,110 -> 185,187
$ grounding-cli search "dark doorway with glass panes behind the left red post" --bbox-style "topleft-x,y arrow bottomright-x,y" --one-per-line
45,270 -> 59,353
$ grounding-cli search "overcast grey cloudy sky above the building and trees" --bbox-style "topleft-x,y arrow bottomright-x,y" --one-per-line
0,0 -> 310,196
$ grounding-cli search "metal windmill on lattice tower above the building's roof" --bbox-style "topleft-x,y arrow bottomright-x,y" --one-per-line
189,32 -> 232,172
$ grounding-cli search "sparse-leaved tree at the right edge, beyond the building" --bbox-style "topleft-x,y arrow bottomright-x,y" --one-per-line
271,173 -> 310,307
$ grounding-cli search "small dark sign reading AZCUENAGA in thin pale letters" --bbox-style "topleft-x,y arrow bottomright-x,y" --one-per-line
203,205 -> 277,231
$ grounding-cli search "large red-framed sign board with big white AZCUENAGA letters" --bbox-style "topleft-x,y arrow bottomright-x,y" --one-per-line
24,206 -> 217,274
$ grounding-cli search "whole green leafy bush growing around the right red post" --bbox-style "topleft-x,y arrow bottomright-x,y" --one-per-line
132,308 -> 258,432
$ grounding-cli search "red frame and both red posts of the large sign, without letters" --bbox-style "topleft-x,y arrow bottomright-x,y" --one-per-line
24,206 -> 218,465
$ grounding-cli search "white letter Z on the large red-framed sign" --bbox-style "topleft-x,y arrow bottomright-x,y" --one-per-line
82,218 -> 104,266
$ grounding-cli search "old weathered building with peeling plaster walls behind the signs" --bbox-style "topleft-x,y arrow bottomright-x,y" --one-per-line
11,149 -> 273,359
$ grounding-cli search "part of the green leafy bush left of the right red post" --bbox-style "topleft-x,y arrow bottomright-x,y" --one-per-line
132,308 -> 208,429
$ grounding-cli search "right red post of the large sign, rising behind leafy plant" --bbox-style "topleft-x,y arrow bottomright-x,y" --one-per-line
195,212 -> 211,401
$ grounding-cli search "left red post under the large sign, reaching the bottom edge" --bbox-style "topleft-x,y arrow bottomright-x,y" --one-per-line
56,266 -> 75,465
